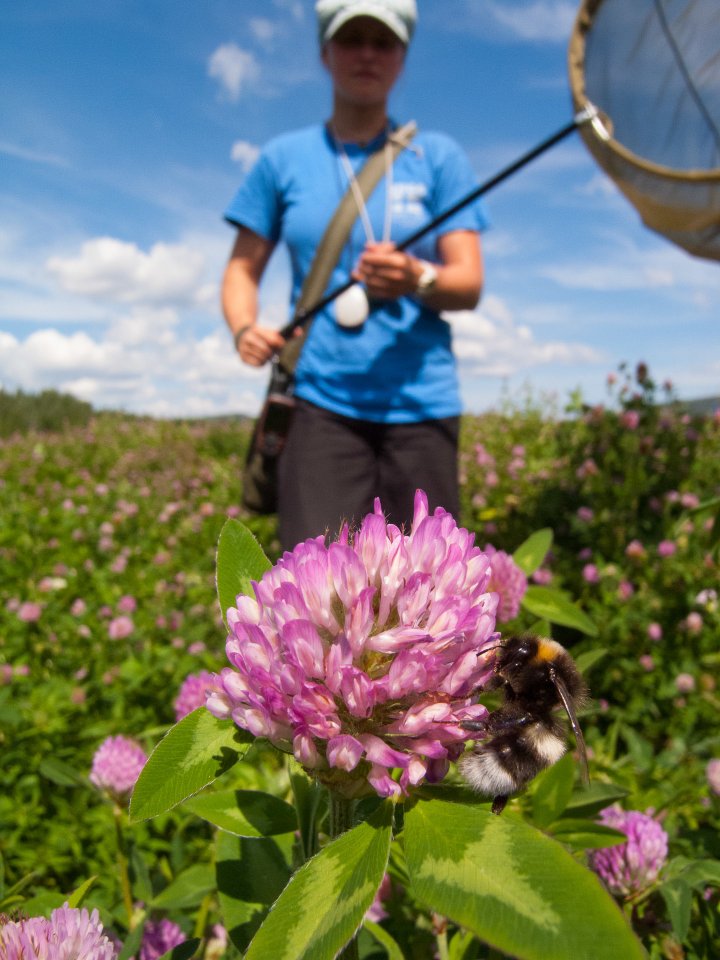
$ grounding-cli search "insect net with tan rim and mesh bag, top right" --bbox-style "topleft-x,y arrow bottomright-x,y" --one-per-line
568,0 -> 720,260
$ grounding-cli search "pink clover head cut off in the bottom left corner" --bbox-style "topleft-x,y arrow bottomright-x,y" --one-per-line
0,903 -> 117,960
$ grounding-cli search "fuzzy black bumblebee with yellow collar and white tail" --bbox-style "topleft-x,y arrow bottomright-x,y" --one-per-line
459,635 -> 589,814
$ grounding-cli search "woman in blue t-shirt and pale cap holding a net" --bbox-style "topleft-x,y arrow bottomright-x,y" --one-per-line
223,0 -> 485,549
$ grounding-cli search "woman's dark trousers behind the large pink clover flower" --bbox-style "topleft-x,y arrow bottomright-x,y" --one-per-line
278,400 -> 460,550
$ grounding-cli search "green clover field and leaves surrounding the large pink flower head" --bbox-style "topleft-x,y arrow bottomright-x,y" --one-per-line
0,369 -> 720,960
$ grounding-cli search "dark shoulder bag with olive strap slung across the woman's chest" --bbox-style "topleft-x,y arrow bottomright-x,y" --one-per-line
242,121 -> 417,514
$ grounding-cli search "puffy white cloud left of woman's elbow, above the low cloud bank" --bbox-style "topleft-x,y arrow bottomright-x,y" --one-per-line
47,237 -> 205,303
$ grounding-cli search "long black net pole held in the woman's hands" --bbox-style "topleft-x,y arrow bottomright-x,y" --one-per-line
279,104 -> 596,340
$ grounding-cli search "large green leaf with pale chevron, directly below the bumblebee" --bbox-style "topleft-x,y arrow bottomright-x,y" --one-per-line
405,800 -> 645,960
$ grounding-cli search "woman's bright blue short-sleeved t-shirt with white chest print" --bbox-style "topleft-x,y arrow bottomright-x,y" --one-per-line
225,125 -> 486,423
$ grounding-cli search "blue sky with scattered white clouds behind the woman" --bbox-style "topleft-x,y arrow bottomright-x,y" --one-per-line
0,0 -> 720,417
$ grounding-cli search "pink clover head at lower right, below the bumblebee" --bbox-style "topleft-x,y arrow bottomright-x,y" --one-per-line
591,805 -> 668,897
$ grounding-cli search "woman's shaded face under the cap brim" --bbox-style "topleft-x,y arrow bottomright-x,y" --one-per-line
322,17 -> 405,106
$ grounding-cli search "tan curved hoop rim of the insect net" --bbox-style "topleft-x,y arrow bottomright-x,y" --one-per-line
568,0 -> 720,183
